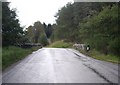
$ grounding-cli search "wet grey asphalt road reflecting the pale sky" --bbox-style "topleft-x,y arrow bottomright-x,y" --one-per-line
2,48 -> 118,83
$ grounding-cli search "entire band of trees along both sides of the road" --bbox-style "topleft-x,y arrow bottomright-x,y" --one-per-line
2,2 -> 120,56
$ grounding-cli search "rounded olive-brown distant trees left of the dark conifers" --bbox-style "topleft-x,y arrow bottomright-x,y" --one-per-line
26,21 -> 48,46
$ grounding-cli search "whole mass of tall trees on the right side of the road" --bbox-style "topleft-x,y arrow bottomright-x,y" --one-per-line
51,2 -> 120,56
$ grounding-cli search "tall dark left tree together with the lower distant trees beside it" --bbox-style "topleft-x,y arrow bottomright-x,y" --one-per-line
2,2 -> 52,47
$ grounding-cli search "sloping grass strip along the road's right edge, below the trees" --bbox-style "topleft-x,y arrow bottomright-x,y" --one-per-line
80,50 -> 120,64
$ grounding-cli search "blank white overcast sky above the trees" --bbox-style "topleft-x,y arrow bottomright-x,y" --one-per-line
8,0 -> 73,27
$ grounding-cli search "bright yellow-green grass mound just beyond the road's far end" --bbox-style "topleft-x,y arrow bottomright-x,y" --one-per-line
47,40 -> 72,48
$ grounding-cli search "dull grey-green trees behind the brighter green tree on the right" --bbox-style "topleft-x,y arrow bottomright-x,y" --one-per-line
54,2 -> 111,42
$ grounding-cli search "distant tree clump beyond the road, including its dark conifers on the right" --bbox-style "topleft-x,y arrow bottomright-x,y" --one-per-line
26,21 -> 53,46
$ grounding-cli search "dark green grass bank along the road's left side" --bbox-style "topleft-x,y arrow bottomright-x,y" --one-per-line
2,46 -> 39,70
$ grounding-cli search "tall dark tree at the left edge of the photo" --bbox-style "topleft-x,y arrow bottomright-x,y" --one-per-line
2,2 -> 24,46
